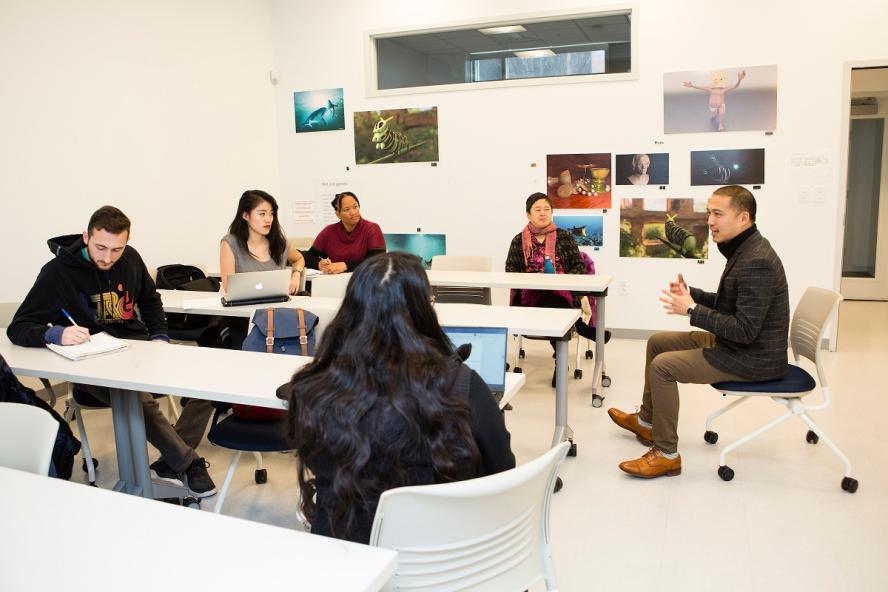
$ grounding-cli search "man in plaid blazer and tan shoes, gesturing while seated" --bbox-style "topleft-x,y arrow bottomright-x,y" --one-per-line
608,185 -> 789,478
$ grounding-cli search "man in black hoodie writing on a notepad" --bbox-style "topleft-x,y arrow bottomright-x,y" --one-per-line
6,206 -> 216,497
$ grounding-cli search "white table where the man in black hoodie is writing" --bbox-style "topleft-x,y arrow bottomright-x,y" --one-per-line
0,334 -> 524,498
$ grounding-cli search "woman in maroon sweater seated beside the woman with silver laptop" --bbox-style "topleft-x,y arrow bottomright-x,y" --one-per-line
305,191 -> 385,273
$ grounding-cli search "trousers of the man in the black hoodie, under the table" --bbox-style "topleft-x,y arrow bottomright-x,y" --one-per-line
75,384 -> 213,473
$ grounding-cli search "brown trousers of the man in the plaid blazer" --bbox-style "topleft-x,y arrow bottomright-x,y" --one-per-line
638,331 -> 750,453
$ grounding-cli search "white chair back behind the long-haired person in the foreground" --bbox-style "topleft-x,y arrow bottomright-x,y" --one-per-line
370,442 -> 570,592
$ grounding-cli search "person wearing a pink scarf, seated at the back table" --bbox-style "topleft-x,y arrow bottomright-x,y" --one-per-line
506,193 -> 596,386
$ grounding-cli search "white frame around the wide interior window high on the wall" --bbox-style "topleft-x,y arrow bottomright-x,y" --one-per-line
364,3 -> 639,97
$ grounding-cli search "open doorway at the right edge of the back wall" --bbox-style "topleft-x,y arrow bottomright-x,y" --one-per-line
841,63 -> 888,300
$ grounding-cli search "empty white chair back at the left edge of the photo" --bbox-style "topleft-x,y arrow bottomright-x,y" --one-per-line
0,403 -> 59,475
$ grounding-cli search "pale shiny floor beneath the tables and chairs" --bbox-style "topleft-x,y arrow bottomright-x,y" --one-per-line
45,303 -> 888,592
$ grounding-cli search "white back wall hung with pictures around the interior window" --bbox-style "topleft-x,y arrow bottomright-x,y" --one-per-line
272,0 -> 888,329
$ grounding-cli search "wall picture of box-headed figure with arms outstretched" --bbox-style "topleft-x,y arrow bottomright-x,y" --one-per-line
663,66 -> 777,134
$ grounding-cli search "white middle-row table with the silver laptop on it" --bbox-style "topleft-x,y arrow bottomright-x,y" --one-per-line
158,292 -> 584,455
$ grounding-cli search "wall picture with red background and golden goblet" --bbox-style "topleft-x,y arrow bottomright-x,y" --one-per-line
546,153 -> 611,210
